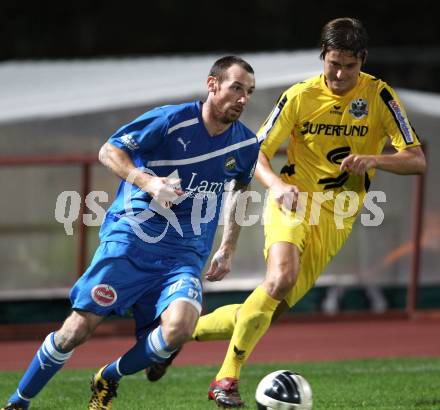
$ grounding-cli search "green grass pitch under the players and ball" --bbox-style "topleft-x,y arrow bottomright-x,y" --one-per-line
0,358 -> 440,410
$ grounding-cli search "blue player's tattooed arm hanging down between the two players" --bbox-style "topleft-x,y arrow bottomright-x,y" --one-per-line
205,181 -> 249,282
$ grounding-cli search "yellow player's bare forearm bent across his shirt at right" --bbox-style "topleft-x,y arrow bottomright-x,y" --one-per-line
341,147 -> 426,175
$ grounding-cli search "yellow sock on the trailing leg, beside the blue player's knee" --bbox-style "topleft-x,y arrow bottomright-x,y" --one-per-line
192,305 -> 241,341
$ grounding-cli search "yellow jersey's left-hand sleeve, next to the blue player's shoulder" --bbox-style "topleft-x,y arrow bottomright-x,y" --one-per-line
257,91 -> 294,159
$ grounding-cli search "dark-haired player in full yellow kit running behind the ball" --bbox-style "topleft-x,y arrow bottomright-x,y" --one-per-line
148,18 -> 426,407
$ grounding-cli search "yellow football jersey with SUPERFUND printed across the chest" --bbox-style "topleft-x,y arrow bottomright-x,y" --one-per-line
257,72 -> 420,216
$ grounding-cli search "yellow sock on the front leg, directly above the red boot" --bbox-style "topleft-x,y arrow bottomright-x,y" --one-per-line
216,287 -> 280,380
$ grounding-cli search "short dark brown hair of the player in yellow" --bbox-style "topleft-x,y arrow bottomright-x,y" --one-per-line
320,17 -> 368,63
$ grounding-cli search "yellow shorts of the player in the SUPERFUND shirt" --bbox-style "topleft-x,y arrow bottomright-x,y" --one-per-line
264,198 -> 356,307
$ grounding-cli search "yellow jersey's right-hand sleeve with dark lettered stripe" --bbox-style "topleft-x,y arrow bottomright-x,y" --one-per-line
380,85 -> 420,151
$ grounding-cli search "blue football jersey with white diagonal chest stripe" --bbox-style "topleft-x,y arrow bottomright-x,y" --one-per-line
100,101 -> 259,268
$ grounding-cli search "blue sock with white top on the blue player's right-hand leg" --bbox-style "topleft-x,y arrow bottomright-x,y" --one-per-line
102,326 -> 173,381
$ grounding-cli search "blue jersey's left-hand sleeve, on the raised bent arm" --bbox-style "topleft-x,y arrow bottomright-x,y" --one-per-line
108,108 -> 168,157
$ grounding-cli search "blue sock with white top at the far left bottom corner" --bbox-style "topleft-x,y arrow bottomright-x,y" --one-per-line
9,332 -> 73,408
